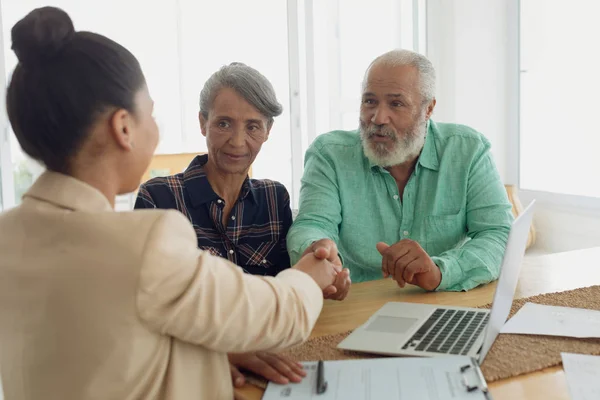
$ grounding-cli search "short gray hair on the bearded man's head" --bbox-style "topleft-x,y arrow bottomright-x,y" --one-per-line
363,49 -> 435,103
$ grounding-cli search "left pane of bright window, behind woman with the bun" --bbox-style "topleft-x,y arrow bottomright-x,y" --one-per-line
2,0 -> 182,208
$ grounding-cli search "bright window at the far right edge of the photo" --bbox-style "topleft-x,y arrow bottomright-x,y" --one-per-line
520,0 -> 600,197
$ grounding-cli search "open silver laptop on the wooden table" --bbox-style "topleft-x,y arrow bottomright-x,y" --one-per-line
338,200 -> 535,363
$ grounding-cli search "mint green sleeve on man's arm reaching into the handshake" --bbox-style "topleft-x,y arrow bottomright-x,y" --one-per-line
287,142 -> 342,265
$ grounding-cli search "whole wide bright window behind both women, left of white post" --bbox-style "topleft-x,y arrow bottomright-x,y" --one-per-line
2,0 -> 291,203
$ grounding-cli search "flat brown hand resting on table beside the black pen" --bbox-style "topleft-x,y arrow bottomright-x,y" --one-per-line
227,351 -> 306,387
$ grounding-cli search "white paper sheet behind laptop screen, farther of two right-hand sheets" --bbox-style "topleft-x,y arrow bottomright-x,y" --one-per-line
500,303 -> 600,338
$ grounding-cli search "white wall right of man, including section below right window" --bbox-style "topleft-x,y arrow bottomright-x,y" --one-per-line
427,0 -> 600,253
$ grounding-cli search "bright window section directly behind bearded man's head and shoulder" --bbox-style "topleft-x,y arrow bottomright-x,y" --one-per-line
292,0 -> 426,205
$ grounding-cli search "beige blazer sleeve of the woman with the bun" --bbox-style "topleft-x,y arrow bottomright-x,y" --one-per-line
137,211 -> 323,352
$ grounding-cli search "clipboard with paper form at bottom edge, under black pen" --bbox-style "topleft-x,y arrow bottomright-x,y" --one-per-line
263,356 -> 489,400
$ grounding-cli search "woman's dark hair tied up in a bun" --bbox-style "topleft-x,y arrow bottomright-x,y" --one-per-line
6,7 -> 146,173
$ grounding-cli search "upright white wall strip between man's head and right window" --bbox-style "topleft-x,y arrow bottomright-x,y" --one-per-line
427,0 -> 514,183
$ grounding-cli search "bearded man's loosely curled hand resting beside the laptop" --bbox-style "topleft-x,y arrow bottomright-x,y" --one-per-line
377,239 -> 442,290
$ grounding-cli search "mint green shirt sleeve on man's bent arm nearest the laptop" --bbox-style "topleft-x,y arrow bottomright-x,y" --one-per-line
432,145 -> 513,291
